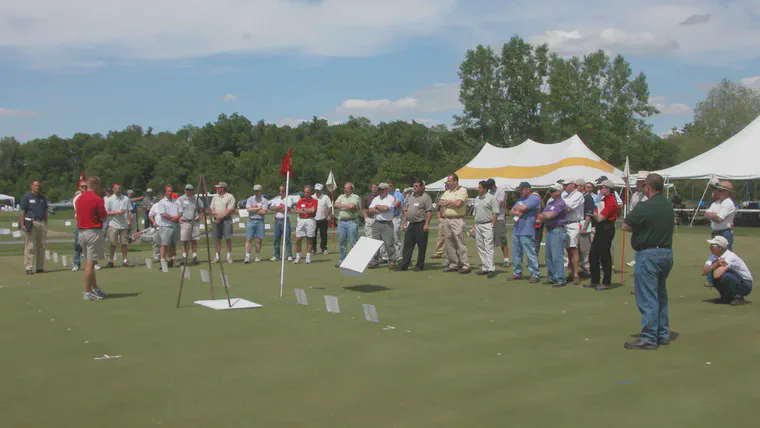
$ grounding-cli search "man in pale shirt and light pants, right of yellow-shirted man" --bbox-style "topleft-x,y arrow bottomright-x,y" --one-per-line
472,180 -> 499,279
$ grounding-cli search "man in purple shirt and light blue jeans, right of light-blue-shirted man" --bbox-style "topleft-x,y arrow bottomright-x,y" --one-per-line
539,183 -> 568,287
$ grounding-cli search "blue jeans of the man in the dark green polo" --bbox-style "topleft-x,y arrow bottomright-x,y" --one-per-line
633,248 -> 673,343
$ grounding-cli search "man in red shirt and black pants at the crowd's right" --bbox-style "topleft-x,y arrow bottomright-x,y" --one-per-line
584,180 -> 618,290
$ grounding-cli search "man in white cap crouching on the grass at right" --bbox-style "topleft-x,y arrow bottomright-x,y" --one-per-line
702,236 -> 753,306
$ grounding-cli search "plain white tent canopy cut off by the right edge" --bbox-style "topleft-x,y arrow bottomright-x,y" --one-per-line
655,117 -> 760,180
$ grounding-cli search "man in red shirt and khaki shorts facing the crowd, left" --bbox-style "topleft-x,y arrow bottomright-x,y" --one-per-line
75,177 -> 107,301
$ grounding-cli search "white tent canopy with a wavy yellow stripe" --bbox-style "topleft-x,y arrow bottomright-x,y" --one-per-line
426,135 -> 624,191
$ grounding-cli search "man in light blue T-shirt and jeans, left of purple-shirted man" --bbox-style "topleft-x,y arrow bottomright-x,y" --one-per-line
510,181 -> 541,284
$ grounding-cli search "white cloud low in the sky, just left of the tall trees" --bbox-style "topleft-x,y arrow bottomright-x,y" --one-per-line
334,83 -> 462,120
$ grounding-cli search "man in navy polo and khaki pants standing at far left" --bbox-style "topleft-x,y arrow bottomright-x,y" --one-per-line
19,181 -> 47,275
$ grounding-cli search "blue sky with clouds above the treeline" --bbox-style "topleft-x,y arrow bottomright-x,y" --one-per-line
0,0 -> 760,140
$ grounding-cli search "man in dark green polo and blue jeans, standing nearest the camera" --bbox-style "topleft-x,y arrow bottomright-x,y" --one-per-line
623,174 -> 673,350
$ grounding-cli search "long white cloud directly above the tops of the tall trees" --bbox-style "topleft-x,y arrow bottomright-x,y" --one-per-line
531,28 -> 678,55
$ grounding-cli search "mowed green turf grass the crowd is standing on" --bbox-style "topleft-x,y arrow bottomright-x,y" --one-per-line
0,212 -> 760,427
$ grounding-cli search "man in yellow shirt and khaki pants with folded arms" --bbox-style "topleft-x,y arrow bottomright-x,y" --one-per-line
438,174 -> 470,274
